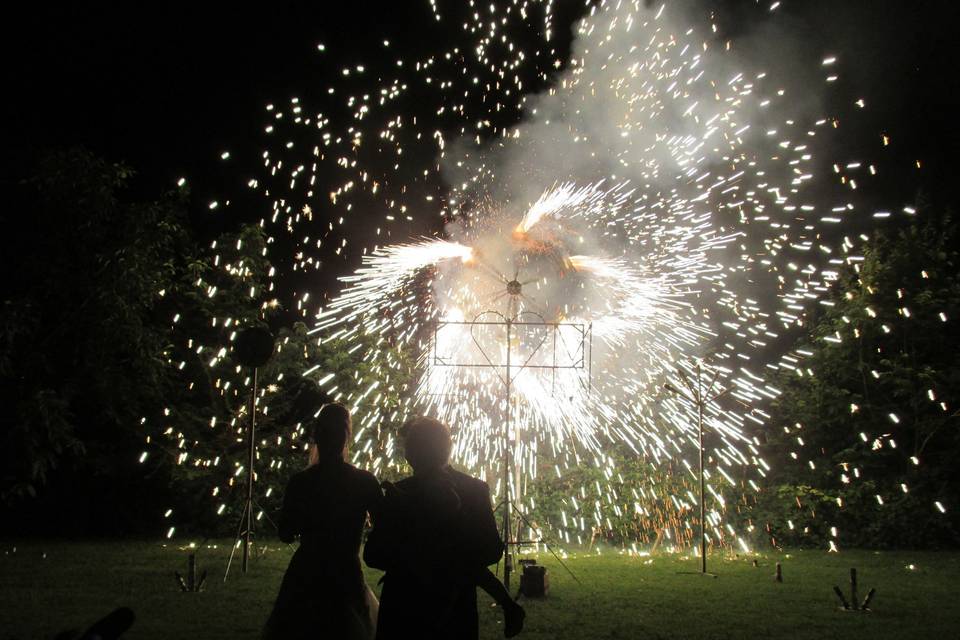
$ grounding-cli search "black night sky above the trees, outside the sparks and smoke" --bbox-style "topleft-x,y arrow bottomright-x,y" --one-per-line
2,0 -> 960,242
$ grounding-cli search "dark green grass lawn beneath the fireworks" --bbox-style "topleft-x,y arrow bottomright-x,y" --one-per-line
0,541 -> 960,640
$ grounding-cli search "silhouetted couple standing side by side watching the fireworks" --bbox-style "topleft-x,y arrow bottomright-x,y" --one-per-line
264,404 -> 524,640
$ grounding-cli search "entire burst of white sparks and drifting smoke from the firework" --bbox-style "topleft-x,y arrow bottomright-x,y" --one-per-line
150,0 -> 943,549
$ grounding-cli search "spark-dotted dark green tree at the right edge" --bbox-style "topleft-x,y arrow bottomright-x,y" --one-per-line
758,212 -> 960,547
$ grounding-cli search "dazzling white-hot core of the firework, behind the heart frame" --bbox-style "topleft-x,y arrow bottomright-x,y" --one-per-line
318,184 -> 738,492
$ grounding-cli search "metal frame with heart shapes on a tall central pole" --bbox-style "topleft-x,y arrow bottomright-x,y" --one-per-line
432,308 -> 593,590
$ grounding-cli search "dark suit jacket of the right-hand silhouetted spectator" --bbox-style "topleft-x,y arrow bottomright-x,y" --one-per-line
363,467 -> 503,640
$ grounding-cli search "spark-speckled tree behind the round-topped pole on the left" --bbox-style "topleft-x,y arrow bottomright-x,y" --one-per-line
132,204 -> 406,535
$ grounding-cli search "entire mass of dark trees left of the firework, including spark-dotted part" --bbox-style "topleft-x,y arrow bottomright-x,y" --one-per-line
0,150 -> 405,534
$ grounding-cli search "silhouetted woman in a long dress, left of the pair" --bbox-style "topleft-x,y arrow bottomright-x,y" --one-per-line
263,404 -> 381,640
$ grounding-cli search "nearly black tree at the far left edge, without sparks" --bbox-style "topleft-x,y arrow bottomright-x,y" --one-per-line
0,150 -> 190,528
